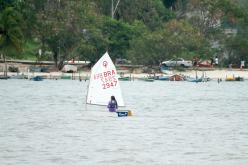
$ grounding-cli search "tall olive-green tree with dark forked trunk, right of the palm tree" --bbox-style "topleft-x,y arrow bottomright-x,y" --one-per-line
30,0 -> 97,69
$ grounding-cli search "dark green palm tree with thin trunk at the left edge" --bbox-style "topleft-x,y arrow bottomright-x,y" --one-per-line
0,7 -> 23,77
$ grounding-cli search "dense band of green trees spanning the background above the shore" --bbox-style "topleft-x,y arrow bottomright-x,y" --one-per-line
0,0 -> 248,69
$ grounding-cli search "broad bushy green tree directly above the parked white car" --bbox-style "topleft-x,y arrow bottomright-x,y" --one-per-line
129,20 -> 210,65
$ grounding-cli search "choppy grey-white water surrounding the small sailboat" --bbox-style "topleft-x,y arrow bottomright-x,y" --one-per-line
0,80 -> 248,165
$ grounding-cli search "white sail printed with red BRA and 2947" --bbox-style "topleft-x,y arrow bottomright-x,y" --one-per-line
87,52 -> 124,106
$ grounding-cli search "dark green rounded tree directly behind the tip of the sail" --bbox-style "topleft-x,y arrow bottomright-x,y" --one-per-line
76,17 -> 145,63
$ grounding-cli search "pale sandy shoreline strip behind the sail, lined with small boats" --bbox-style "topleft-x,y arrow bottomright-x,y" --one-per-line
0,69 -> 248,80
